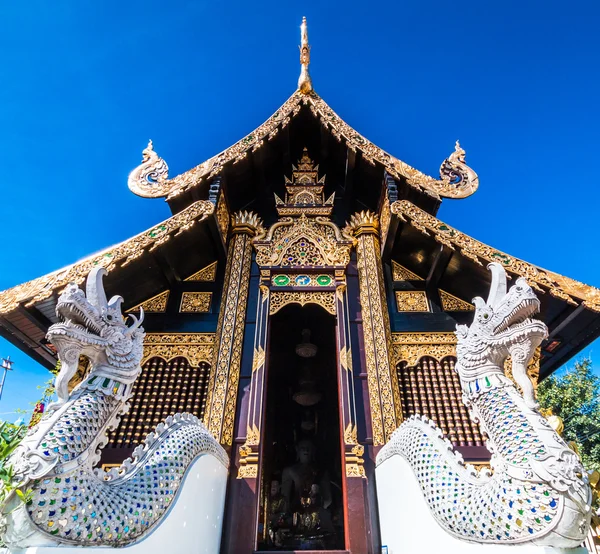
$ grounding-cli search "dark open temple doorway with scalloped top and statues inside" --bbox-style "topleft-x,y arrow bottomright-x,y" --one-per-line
258,304 -> 345,551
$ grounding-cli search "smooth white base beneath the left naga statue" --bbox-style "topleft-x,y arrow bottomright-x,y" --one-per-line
7,455 -> 227,554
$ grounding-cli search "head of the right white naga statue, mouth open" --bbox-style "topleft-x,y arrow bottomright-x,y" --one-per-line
456,263 -> 548,407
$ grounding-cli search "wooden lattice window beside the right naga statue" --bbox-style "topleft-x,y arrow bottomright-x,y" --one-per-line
397,356 -> 484,446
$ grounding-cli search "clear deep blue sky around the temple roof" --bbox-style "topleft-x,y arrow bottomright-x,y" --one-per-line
0,0 -> 600,419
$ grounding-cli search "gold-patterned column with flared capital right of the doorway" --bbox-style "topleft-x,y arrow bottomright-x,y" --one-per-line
350,212 -> 402,446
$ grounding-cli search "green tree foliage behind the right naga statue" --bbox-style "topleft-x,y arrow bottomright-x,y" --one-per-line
537,358 -> 600,471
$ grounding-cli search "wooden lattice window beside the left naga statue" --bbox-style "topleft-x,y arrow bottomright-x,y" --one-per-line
108,357 -> 210,448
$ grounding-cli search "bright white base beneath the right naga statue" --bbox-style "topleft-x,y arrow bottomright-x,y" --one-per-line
375,450 -> 588,554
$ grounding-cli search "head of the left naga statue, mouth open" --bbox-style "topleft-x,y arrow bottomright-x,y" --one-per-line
47,267 -> 144,404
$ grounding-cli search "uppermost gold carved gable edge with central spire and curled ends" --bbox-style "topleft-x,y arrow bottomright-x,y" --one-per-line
128,18 -> 479,204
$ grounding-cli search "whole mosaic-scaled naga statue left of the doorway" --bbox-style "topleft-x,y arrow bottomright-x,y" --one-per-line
1,268 -> 228,549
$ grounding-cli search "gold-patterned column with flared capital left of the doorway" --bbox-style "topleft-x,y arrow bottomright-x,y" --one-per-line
204,212 -> 262,445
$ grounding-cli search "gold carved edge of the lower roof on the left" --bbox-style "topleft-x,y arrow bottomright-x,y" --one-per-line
0,200 -> 215,314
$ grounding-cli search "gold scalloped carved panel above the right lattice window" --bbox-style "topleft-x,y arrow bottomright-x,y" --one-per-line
392,333 -> 456,367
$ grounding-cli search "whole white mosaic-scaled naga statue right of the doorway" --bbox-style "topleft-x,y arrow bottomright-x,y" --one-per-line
377,263 -> 592,548
